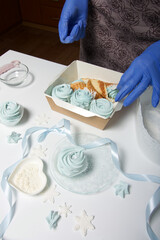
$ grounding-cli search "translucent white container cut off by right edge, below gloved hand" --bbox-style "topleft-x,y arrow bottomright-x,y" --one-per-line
137,87 -> 160,165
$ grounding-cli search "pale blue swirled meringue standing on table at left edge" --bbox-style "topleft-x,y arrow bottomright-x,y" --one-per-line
0,102 -> 24,126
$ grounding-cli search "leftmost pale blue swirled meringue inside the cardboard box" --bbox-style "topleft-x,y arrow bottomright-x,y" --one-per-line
52,84 -> 73,102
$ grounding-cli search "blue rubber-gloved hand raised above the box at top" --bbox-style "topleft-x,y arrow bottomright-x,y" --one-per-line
58,0 -> 88,43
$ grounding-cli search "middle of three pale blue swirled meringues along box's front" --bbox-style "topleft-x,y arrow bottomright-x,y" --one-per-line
71,89 -> 93,110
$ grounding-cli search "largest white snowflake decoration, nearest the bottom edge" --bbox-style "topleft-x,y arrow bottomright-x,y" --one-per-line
75,210 -> 95,236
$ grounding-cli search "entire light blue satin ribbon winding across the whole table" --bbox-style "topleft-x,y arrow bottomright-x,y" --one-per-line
0,119 -> 160,240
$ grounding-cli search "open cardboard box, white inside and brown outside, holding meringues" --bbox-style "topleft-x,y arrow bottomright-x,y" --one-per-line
45,60 -> 122,129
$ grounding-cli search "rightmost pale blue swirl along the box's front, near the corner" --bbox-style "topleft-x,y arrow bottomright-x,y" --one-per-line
90,98 -> 113,118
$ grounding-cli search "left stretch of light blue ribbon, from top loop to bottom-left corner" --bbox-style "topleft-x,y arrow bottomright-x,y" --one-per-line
0,119 -> 74,240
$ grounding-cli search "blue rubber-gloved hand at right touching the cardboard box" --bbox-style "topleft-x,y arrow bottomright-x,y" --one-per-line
115,41 -> 160,107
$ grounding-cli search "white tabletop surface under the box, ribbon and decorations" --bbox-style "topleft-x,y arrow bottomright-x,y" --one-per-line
0,50 -> 160,240
